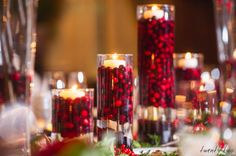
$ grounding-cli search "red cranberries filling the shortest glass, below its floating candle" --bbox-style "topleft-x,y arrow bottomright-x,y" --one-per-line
52,96 -> 93,138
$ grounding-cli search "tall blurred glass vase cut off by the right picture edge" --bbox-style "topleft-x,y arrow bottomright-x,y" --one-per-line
213,0 -> 236,149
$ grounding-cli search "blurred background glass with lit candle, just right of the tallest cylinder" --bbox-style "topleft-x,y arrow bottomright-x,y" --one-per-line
174,52 -> 203,109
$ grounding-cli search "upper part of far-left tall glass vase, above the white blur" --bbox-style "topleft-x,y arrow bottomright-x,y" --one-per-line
0,0 -> 37,104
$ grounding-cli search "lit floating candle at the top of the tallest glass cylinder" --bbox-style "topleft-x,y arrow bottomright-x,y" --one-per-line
143,5 -> 164,19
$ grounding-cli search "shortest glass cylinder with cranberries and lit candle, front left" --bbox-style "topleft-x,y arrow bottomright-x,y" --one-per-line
52,88 -> 94,142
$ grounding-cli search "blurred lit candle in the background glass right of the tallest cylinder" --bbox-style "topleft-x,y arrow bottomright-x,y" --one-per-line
178,52 -> 198,68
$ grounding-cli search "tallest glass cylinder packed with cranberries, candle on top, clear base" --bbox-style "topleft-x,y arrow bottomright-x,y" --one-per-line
137,4 -> 175,143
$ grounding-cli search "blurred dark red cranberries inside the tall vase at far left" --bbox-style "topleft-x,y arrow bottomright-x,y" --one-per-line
0,71 -> 31,104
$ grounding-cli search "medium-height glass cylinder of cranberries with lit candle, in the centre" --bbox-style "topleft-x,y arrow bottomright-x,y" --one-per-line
97,54 -> 133,147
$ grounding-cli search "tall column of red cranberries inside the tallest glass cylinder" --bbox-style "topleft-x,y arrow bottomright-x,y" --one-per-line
138,17 -> 174,108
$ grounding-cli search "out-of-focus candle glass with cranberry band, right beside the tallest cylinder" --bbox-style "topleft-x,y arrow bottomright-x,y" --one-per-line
174,52 -> 203,124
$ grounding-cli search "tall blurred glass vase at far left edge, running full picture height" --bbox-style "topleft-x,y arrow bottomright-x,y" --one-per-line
0,0 -> 37,155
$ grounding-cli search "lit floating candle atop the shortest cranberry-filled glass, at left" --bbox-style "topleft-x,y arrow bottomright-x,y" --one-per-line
60,86 -> 85,99
